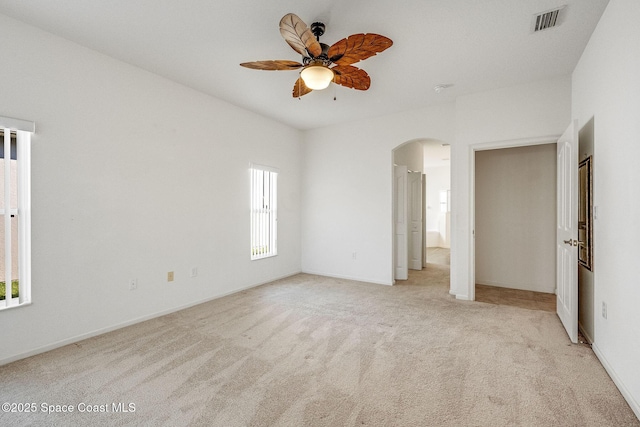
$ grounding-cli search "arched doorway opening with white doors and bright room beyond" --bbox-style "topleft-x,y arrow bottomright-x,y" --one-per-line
392,139 -> 451,281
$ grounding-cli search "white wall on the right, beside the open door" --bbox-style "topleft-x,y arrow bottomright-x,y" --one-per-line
572,0 -> 640,417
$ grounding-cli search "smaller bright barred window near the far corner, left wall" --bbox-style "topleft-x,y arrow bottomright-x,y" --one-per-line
250,164 -> 278,260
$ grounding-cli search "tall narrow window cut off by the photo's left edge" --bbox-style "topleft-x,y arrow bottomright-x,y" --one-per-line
0,117 -> 34,310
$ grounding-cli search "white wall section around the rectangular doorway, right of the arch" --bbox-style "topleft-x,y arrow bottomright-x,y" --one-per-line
451,76 -> 571,299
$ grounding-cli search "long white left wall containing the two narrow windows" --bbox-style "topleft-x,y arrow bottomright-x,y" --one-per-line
0,16 -> 301,363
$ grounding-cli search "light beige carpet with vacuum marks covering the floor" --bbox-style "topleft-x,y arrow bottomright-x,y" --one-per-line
0,265 -> 640,427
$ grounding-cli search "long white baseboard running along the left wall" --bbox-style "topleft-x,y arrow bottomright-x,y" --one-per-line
0,271 -> 301,366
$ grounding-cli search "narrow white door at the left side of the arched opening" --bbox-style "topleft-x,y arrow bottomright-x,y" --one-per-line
393,166 -> 409,280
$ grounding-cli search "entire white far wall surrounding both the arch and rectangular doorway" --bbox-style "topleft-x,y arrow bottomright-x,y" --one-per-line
302,76 -> 571,290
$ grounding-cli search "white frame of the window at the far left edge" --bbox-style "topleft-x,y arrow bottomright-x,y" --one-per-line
0,117 -> 35,311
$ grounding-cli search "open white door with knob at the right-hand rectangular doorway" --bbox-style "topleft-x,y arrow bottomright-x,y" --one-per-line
556,120 -> 578,343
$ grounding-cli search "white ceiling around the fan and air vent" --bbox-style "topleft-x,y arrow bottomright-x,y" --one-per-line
0,0 -> 608,129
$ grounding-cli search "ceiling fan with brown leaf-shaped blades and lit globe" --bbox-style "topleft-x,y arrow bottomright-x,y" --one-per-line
240,13 -> 393,98
